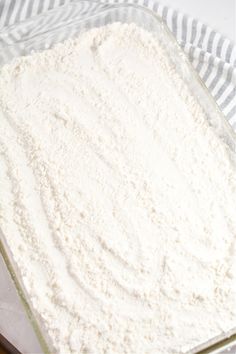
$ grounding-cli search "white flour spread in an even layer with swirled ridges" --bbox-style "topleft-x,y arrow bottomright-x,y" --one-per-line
0,24 -> 236,354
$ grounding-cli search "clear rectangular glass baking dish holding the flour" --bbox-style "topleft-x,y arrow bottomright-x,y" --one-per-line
0,1 -> 236,354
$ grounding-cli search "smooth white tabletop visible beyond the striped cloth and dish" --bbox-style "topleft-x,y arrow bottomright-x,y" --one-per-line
0,0 -> 236,354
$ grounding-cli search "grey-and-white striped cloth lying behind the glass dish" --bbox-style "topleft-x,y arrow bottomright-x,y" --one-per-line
0,0 -> 236,130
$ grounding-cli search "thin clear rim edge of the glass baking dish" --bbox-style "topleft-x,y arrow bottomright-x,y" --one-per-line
0,0 -> 236,354
